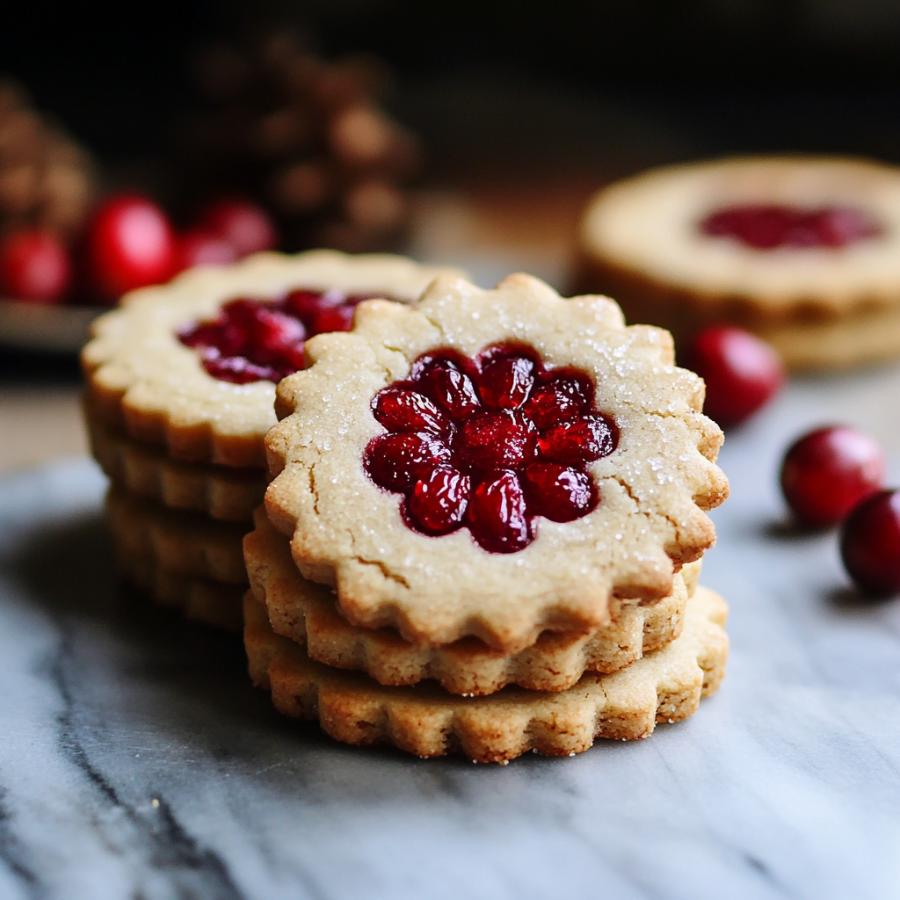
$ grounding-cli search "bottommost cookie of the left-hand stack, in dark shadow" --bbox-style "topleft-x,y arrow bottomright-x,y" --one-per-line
117,552 -> 244,633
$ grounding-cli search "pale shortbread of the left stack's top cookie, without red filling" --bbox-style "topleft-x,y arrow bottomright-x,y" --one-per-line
81,250 -> 460,467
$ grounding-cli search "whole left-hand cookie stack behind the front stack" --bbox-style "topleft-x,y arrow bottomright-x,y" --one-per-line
82,251 -> 458,629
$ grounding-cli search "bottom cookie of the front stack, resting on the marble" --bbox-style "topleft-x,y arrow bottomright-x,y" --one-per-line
244,587 -> 728,762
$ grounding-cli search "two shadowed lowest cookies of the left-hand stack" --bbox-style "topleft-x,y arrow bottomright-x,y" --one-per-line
106,486 -> 247,631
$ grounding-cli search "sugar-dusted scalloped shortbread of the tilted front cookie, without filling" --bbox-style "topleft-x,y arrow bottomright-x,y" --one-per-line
266,275 -> 728,653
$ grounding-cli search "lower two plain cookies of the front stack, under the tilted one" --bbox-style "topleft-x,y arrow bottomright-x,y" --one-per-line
244,513 -> 728,762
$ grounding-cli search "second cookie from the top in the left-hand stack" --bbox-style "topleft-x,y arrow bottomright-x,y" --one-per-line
86,410 -> 266,523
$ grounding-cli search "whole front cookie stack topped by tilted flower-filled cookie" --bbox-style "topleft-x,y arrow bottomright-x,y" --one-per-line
244,275 -> 728,762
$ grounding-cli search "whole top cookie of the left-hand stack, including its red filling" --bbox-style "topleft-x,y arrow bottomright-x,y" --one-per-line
82,250 -> 460,467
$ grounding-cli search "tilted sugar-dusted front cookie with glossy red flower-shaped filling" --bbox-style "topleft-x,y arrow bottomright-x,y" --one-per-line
266,275 -> 728,654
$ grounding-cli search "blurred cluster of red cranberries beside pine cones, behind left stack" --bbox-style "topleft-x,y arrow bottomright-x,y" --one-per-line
0,194 -> 277,304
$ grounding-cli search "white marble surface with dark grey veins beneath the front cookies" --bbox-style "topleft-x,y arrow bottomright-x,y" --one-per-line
0,369 -> 900,900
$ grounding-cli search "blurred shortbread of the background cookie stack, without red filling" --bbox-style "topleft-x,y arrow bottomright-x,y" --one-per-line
575,156 -> 900,368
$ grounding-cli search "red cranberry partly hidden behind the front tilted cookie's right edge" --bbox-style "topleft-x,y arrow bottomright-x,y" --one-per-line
686,325 -> 784,428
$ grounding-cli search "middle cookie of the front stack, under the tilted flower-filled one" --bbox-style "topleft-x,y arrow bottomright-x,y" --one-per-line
244,513 -> 700,696
